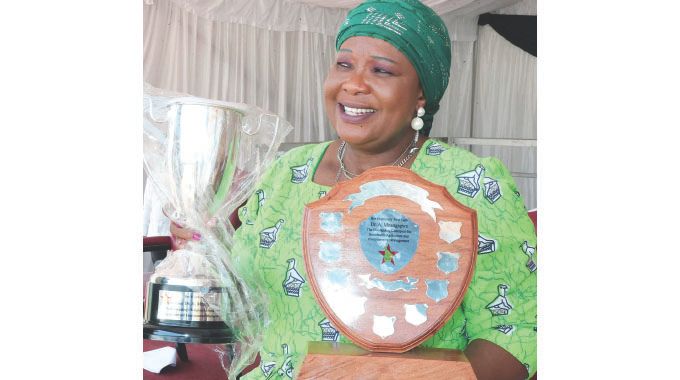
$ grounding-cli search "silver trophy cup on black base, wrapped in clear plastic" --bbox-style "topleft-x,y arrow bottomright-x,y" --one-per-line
144,89 -> 291,378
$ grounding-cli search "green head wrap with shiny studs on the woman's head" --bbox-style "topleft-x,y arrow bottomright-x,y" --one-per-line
335,0 -> 451,136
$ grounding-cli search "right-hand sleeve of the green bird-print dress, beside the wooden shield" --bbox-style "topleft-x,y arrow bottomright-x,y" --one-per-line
462,158 -> 537,376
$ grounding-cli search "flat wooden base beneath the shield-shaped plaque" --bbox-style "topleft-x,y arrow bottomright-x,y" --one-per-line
298,342 -> 477,380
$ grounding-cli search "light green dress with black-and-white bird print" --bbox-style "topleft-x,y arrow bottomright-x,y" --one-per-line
233,140 -> 537,379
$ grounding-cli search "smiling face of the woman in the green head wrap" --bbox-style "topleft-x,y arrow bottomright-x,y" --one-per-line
324,36 -> 425,152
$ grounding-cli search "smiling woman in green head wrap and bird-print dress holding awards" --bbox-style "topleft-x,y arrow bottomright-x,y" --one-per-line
172,0 -> 536,379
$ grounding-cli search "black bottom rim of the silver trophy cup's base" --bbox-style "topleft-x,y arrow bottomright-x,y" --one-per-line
144,323 -> 236,344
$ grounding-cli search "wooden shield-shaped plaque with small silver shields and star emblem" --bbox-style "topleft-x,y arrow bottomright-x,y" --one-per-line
303,166 -> 477,352
